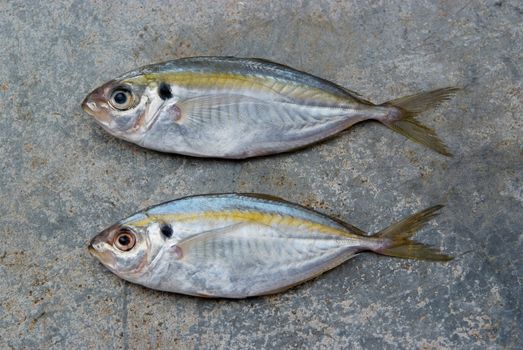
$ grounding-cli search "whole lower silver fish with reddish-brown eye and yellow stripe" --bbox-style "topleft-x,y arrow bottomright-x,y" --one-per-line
89,194 -> 452,298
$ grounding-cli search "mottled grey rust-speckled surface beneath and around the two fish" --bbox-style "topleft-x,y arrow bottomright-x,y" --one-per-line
0,0 -> 523,349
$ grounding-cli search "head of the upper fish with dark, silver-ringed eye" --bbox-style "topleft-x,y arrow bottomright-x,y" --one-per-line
82,78 -> 161,141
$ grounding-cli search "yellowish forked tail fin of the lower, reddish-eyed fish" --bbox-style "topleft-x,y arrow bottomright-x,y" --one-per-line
373,205 -> 452,261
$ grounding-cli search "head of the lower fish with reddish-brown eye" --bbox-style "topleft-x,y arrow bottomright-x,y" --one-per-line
89,223 -> 163,281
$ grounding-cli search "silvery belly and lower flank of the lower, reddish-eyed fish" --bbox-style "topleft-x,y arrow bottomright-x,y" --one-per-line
146,222 -> 358,298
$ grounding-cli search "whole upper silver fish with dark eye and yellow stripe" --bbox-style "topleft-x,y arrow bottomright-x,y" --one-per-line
82,57 -> 457,159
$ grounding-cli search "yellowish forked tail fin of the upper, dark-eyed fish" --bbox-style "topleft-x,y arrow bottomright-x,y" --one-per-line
378,87 -> 459,157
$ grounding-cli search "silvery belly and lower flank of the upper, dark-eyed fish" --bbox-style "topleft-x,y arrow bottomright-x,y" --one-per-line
145,79 -> 366,158
